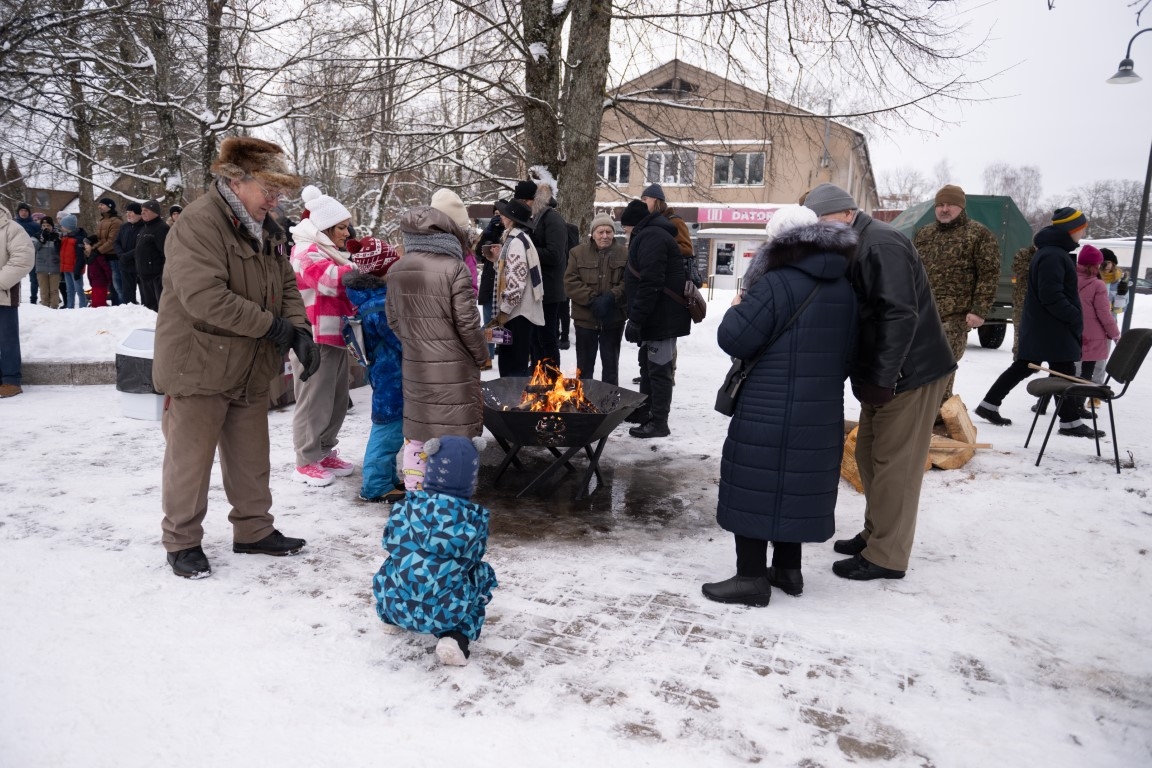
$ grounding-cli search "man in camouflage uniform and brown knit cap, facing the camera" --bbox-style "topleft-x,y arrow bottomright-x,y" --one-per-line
914,184 -> 1000,400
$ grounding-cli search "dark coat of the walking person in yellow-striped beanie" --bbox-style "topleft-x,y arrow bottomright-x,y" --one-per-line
1017,227 -> 1084,363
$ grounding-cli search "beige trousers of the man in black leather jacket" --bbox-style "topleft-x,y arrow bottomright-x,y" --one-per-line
856,377 -> 948,571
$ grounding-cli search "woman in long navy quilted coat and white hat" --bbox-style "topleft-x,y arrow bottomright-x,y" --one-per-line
703,206 -> 856,606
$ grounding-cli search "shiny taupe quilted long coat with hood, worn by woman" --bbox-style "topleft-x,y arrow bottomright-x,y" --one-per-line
387,206 -> 488,441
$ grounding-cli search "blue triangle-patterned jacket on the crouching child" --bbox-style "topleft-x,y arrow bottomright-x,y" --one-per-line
372,491 -> 497,640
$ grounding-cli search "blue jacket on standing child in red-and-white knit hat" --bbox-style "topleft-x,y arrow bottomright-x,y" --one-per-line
343,271 -> 404,424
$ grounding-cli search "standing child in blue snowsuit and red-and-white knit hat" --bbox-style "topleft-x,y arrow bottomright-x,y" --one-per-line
343,237 -> 404,503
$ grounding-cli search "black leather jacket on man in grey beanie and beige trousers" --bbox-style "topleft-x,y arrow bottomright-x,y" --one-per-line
849,212 -> 956,393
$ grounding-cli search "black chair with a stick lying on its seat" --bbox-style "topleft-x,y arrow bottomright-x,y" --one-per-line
1024,328 -> 1152,474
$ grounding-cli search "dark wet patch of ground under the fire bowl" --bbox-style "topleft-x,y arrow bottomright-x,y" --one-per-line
475,431 -> 719,539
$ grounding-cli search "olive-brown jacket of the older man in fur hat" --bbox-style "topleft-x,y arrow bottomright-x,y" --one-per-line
152,189 -> 309,400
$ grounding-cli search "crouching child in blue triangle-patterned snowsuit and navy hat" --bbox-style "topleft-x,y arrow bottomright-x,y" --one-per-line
372,435 -> 497,667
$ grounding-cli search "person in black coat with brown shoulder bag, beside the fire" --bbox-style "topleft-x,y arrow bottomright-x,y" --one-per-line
620,200 -> 692,438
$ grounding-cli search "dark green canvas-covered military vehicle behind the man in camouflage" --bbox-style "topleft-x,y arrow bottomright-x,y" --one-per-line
892,195 -> 1032,349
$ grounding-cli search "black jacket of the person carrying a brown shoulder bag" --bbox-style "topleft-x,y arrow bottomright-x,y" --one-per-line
624,213 -> 692,341
